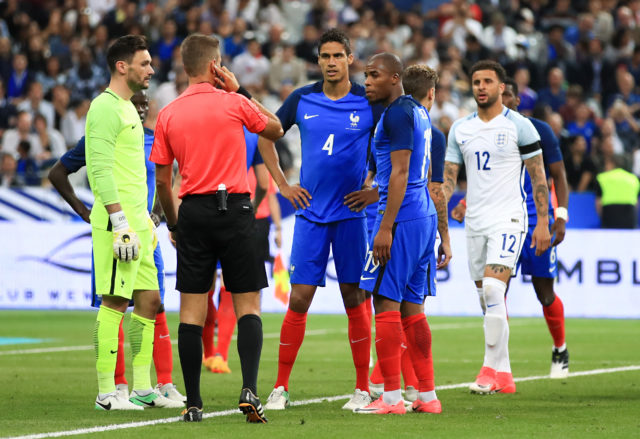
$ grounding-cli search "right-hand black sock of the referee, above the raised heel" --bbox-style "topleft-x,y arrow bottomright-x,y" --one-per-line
238,314 -> 262,396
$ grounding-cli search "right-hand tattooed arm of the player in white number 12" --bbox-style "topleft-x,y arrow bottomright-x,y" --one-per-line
524,154 -> 551,256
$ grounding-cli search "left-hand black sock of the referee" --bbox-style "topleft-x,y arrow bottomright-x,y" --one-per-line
178,323 -> 202,409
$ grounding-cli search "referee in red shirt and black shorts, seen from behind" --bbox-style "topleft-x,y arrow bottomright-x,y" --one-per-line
151,34 -> 283,423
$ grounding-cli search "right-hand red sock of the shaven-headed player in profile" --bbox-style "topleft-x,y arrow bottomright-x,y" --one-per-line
402,314 -> 435,392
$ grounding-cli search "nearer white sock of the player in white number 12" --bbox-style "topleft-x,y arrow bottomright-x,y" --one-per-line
482,277 -> 511,372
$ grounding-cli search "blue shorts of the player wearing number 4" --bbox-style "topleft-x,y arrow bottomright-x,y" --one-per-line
289,215 -> 367,287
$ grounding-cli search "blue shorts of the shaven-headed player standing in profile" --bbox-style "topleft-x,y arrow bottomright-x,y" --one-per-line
360,215 -> 438,304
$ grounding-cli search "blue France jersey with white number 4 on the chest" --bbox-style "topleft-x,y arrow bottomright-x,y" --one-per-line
276,81 -> 375,223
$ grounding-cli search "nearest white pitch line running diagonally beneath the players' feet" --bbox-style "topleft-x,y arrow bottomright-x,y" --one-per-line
0,365 -> 640,439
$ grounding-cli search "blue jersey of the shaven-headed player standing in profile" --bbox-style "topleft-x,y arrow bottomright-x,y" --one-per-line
373,95 -> 432,222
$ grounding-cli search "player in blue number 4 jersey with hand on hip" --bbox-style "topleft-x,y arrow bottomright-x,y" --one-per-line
258,29 -> 375,410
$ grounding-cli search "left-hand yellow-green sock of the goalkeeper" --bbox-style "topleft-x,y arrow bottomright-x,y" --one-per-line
93,305 -> 124,394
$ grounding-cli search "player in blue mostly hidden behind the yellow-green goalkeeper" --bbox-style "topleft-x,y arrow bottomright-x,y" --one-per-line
49,91 -> 185,408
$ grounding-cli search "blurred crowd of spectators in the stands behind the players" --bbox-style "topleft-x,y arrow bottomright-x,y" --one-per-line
0,0 -> 640,202
